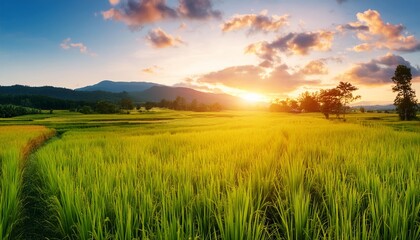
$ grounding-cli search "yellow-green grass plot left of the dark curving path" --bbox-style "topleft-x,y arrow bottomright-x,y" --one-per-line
0,126 -> 51,239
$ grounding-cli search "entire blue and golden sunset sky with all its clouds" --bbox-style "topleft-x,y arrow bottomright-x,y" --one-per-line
0,0 -> 420,103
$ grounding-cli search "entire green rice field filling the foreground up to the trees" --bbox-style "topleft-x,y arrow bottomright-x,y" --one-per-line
0,111 -> 420,239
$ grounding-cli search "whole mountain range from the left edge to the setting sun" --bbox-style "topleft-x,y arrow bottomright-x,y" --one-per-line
0,80 -> 242,108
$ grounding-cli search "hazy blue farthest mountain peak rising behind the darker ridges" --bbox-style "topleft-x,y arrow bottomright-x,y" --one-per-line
75,80 -> 163,93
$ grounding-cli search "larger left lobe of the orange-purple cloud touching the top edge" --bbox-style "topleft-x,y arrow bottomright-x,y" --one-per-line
102,0 -> 178,28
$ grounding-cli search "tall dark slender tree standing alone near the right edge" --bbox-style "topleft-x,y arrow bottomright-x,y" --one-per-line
391,65 -> 418,121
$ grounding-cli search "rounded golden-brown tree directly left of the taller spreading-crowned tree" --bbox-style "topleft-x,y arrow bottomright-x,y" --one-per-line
318,88 -> 342,119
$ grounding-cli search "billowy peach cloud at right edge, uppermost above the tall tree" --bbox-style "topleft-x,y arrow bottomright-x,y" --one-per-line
338,9 -> 420,52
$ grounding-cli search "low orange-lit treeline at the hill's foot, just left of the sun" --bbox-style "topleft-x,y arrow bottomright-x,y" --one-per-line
142,96 -> 223,112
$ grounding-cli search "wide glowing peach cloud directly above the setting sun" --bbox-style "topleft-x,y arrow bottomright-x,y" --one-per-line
197,64 -> 319,93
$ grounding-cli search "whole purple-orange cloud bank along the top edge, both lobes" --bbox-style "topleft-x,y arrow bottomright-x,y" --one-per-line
102,0 -> 221,29
